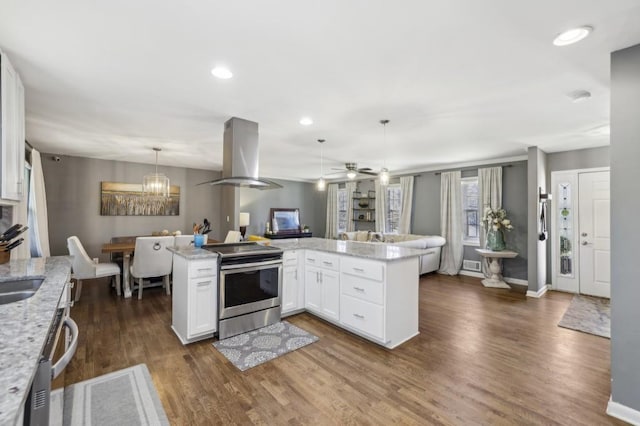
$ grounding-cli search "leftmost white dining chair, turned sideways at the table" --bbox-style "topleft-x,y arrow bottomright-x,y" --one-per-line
67,235 -> 121,302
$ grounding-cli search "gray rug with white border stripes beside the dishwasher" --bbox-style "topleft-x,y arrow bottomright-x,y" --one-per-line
55,364 -> 169,426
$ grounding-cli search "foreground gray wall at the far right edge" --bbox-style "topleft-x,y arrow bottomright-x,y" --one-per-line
611,45 -> 640,413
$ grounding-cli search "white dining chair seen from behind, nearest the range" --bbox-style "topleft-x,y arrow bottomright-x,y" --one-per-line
130,236 -> 175,299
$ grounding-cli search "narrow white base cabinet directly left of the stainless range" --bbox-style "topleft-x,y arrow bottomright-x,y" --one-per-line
171,254 -> 218,344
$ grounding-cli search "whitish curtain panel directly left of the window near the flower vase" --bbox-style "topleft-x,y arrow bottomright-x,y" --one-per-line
438,170 -> 464,275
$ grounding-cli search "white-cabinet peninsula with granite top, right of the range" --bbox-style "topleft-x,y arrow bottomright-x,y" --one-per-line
271,238 -> 426,349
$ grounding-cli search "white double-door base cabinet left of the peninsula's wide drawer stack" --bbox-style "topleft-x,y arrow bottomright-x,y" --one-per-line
304,250 -> 340,321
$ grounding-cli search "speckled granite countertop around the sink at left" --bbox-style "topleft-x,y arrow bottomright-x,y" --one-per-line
0,256 -> 71,425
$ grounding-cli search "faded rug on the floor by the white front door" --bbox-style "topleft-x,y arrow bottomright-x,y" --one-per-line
558,294 -> 611,339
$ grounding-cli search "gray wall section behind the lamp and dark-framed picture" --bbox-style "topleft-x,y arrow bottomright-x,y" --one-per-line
239,179 -> 327,238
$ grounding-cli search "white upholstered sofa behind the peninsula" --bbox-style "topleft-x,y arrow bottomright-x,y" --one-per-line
338,231 -> 447,274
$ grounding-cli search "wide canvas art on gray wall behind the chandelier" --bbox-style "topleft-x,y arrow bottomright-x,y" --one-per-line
100,182 -> 180,216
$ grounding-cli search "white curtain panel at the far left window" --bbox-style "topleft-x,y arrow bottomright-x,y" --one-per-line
29,149 -> 51,257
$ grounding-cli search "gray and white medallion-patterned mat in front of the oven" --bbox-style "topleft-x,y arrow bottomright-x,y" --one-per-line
213,321 -> 318,371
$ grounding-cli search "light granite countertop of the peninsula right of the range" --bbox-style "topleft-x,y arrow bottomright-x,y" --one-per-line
271,237 -> 428,261
